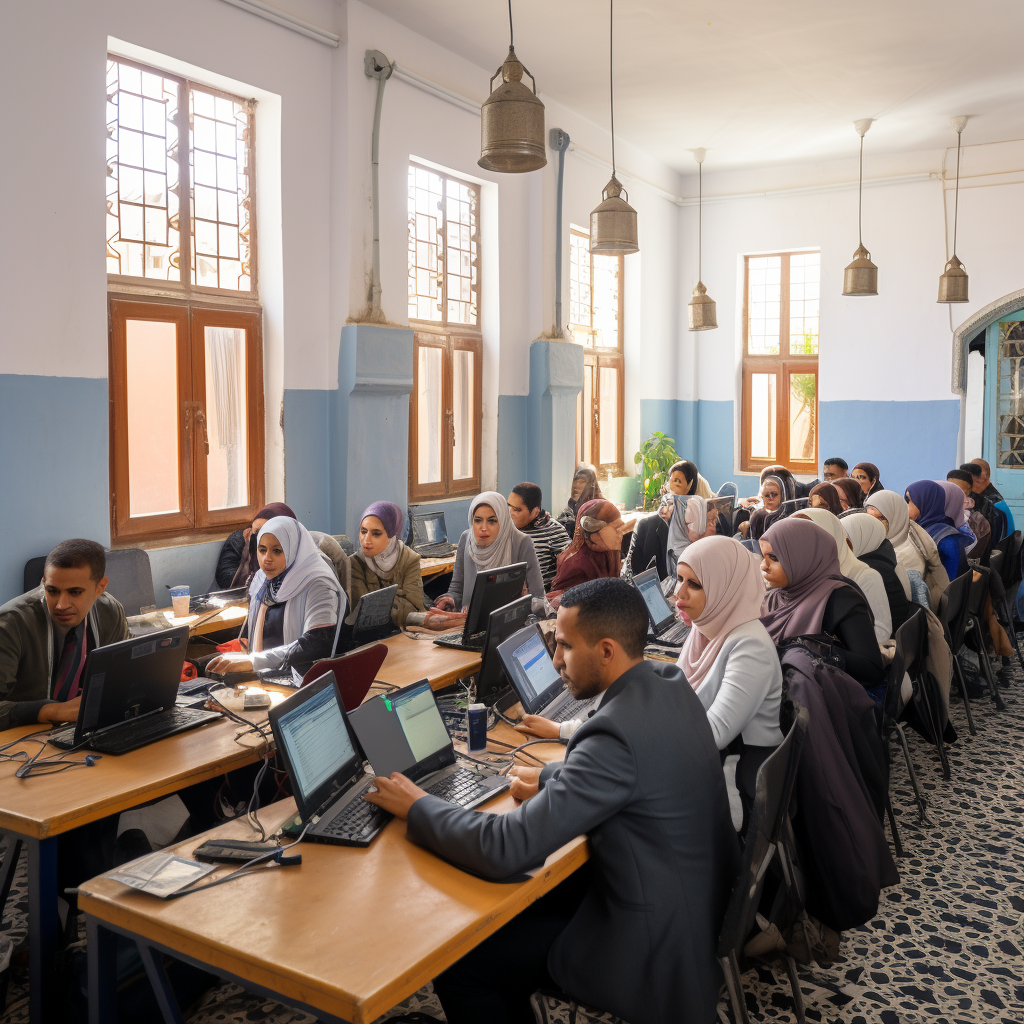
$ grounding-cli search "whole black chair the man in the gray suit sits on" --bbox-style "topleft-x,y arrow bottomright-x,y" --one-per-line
718,707 -> 810,1024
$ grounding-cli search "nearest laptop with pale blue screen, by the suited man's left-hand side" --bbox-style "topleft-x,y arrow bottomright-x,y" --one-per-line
270,672 -> 391,846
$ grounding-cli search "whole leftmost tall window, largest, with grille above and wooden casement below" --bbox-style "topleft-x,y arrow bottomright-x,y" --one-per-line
106,56 -> 264,541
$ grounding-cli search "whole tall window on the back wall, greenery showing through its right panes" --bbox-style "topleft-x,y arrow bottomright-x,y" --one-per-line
740,252 -> 820,473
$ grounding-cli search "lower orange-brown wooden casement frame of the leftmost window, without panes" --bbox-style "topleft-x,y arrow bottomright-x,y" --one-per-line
110,295 -> 265,546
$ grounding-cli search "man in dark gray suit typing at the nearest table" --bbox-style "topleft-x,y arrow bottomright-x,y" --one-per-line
367,580 -> 739,1024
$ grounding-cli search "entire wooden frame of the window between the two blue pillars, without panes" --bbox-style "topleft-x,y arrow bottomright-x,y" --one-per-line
409,160 -> 483,503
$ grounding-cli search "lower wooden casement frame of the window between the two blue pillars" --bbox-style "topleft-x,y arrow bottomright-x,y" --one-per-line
409,329 -> 483,502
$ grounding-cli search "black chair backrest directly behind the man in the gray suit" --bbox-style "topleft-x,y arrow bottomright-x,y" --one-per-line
718,706 -> 810,956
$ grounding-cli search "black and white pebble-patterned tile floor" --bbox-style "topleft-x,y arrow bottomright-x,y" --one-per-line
0,651 -> 1024,1024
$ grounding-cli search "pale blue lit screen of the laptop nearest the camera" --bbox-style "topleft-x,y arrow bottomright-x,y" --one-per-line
274,673 -> 358,816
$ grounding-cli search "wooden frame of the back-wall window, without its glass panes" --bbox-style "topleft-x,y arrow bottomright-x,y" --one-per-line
739,249 -> 820,475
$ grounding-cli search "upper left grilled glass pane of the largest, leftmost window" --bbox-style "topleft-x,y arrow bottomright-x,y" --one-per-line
106,60 -> 180,281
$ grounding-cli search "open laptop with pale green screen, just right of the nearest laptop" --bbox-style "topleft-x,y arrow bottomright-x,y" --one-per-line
348,679 -> 509,807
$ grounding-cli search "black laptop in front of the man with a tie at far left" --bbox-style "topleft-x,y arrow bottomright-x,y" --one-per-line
46,626 -> 221,754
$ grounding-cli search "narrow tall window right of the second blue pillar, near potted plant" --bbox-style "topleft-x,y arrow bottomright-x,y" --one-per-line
569,227 -> 624,473
